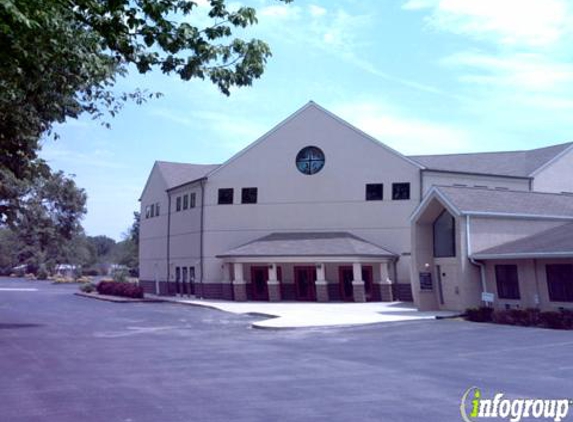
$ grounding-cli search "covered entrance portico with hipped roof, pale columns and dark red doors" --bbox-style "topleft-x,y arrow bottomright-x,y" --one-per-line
218,233 -> 397,302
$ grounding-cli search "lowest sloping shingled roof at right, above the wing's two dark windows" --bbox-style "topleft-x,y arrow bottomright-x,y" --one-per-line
472,223 -> 573,259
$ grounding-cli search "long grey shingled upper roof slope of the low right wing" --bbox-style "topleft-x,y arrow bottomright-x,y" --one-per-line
435,186 -> 573,219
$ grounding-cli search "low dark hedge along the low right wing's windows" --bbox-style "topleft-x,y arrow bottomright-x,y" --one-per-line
465,306 -> 573,330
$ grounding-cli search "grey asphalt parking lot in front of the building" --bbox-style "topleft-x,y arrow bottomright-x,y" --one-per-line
0,279 -> 573,422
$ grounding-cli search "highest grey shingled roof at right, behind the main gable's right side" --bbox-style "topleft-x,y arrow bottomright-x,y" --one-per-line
409,142 -> 573,178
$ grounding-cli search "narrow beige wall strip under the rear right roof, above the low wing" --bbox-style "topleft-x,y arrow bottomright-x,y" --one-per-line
422,170 -> 529,194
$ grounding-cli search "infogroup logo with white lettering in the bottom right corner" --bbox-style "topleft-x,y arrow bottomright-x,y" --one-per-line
460,387 -> 573,422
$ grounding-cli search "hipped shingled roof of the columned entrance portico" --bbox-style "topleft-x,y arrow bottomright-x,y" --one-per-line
217,232 -> 397,258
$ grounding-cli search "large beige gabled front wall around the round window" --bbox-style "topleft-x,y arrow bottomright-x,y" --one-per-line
201,107 -> 420,283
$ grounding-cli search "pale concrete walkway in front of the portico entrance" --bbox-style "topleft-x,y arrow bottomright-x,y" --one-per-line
146,295 -> 459,329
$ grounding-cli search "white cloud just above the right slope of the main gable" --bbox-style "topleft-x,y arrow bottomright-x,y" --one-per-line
333,101 -> 471,155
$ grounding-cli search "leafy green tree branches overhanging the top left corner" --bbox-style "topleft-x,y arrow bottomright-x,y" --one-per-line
0,0 -> 291,223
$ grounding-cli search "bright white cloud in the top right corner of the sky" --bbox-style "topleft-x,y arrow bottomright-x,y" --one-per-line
403,0 -> 572,47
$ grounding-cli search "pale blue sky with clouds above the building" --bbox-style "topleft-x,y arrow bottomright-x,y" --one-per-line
41,0 -> 573,239
